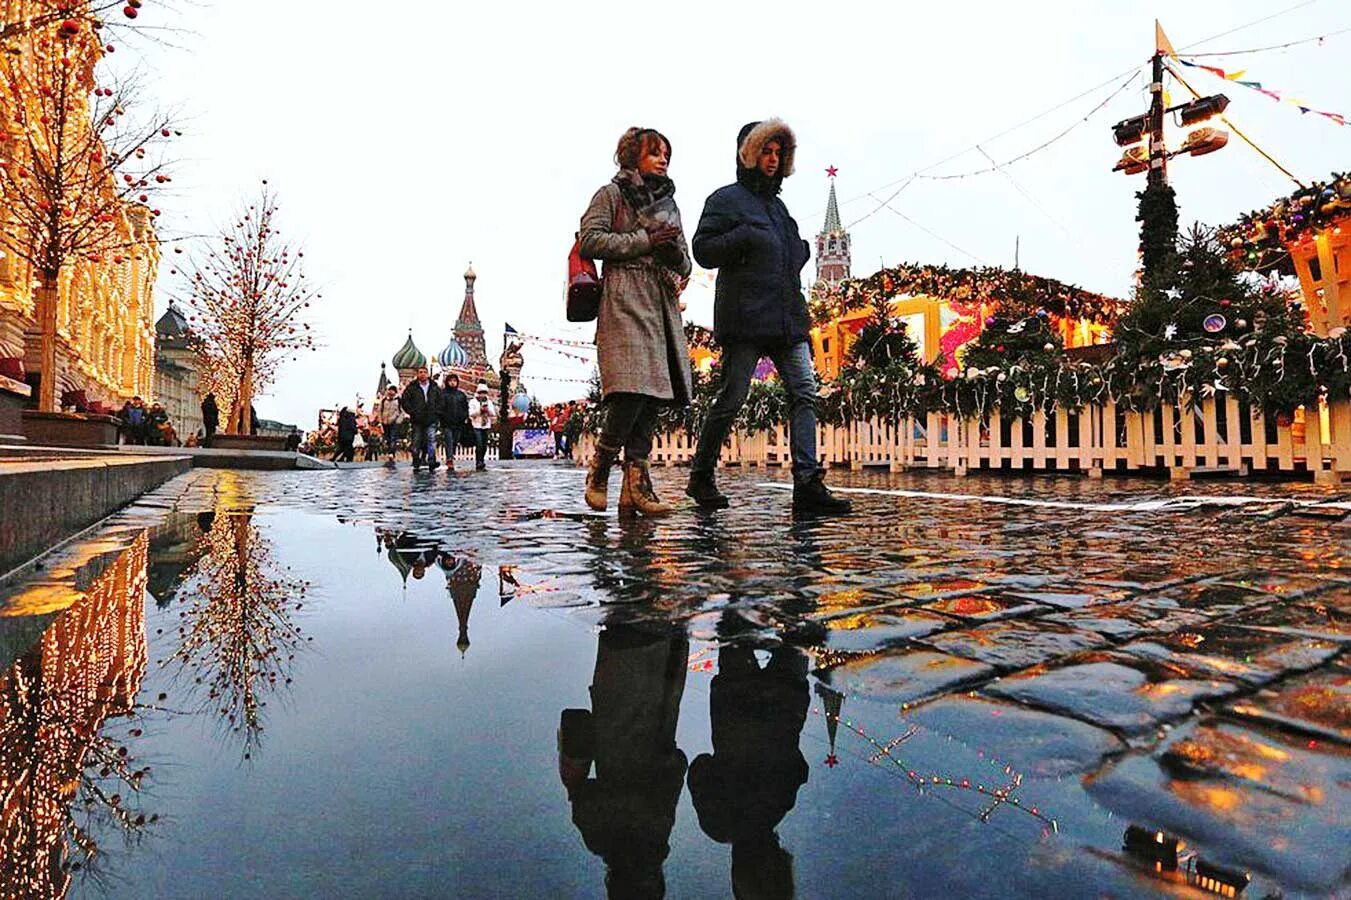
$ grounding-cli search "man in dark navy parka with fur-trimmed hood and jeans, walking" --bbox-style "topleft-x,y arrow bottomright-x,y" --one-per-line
685,119 -> 850,514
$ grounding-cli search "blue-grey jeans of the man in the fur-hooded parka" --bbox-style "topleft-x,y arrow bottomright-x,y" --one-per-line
690,341 -> 821,481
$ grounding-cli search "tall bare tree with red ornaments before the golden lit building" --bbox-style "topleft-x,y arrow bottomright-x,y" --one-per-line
0,9 -> 174,409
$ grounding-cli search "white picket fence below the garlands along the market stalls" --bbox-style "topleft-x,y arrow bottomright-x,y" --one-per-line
576,399 -> 1351,481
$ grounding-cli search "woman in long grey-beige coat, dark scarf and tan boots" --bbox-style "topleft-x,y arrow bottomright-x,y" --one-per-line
581,128 -> 690,516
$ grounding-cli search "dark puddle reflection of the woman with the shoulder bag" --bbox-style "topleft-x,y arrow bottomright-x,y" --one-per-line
558,626 -> 689,897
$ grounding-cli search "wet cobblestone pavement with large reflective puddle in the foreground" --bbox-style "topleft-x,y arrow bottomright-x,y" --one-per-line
0,464 -> 1351,897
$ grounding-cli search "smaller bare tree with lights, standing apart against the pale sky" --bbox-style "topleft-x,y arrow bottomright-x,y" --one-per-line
180,181 -> 322,434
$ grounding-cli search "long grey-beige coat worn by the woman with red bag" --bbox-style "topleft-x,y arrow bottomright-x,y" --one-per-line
581,184 -> 692,404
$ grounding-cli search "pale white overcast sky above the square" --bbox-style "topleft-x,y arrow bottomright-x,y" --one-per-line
129,0 -> 1351,427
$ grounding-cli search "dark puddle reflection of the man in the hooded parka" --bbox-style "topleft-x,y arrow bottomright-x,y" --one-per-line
689,646 -> 809,897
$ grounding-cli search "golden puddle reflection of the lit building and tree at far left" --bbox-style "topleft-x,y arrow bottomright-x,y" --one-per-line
0,535 -> 155,897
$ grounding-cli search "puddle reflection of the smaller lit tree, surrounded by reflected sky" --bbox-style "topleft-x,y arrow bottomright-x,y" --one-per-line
172,511 -> 309,759
